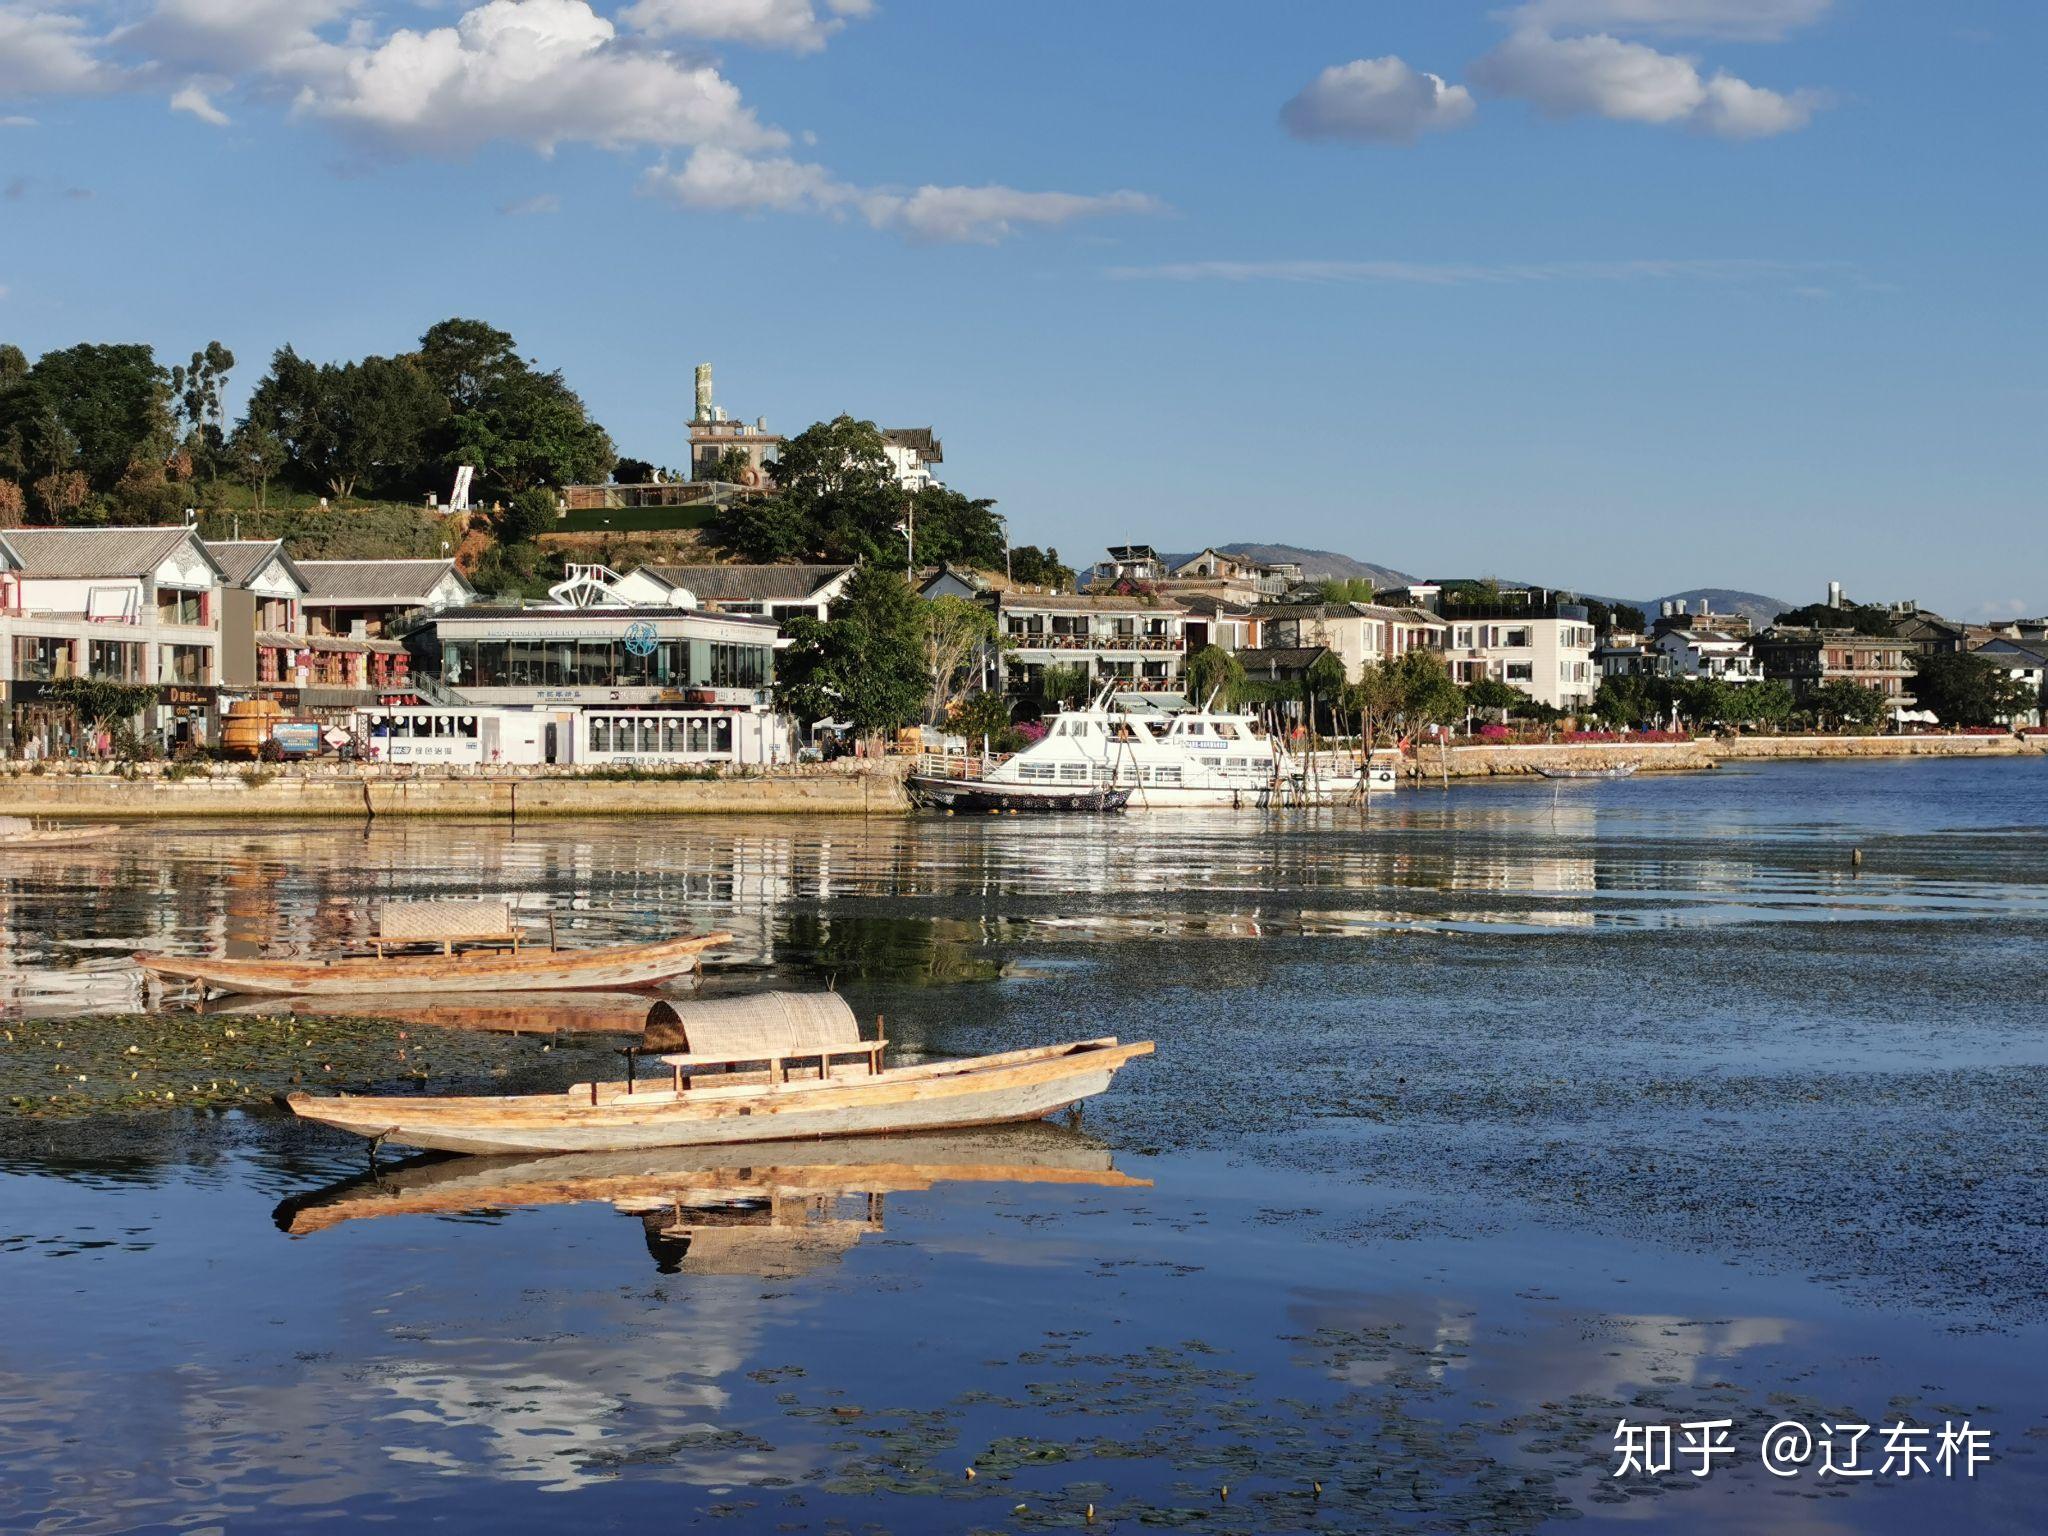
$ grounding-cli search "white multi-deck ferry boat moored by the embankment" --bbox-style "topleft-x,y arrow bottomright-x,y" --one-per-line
911,688 -> 1395,809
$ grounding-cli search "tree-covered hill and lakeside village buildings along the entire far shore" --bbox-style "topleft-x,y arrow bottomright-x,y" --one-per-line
0,322 -> 2048,770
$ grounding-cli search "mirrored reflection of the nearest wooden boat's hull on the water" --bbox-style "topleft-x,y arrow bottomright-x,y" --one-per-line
276,1124 -> 1151,1237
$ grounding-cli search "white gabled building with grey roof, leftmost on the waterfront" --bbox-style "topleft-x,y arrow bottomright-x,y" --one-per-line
0,528 -> 223,756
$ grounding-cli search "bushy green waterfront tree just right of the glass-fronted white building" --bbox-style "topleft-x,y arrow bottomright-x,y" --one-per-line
776,565 -> 930,731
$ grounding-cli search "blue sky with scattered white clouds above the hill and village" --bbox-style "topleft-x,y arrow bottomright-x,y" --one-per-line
0,0 -> 2048,616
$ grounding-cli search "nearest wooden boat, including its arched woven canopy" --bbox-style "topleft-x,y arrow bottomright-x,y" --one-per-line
285,993 -> 1153,1153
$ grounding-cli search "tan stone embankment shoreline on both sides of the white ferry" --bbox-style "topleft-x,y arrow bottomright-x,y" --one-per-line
0,735 -> 2048,821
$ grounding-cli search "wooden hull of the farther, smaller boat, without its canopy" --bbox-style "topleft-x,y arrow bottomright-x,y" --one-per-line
135,932 -> 733,997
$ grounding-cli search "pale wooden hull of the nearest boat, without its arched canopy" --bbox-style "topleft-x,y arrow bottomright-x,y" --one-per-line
285,1038 -> 1153,1153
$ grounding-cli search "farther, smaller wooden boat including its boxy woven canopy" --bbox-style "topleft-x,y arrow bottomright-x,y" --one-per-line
135,901 -> 733,997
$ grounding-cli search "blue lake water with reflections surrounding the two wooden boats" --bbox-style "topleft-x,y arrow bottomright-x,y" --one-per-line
0,760 -> 2048,1532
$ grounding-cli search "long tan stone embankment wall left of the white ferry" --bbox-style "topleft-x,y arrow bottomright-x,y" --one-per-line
0,762 -> 909,819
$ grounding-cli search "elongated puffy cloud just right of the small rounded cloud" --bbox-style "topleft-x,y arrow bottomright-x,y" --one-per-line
1473,31 -> 1819,139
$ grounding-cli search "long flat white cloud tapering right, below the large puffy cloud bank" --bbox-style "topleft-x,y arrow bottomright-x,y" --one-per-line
643,145 -> 1159,246
